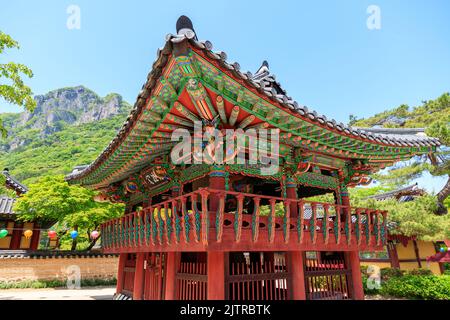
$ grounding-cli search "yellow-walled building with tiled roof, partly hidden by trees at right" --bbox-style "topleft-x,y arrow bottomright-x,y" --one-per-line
361,183 -> 446,274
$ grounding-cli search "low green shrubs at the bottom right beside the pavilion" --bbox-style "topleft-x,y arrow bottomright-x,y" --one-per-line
361,267 -> 450,300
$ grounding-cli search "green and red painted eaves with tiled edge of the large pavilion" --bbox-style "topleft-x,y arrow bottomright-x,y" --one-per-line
66,16 -> 440,187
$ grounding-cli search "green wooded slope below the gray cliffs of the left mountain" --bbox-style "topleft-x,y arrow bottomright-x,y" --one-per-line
0,114 -> 126,184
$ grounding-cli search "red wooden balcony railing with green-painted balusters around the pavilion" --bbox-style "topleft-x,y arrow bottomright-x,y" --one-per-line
101,188 -> 387,252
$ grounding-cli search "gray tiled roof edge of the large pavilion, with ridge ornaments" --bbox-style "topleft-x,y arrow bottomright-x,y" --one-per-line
66,16 -> 440,180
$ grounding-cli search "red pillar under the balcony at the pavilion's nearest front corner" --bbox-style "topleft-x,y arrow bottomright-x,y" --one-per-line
206,251 -> 225,300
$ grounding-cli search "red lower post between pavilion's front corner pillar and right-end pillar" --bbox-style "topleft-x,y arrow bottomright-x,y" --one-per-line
286,251 -> 306,300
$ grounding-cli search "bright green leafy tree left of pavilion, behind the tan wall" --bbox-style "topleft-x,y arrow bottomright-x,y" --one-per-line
14,175 -> 124,250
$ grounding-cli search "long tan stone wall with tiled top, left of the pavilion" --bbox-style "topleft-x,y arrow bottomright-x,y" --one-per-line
0,252 -> 119,282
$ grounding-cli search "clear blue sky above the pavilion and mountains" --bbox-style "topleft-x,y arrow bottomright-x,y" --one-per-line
0,0 -> 450,190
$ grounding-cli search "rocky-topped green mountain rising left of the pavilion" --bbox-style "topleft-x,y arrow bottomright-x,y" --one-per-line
0,86 -> 131,184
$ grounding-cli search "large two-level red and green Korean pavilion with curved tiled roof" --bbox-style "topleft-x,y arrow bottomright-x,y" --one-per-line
66,16 -> 439,300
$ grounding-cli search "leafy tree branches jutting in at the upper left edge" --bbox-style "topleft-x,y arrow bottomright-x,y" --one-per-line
0,31 -> 36,138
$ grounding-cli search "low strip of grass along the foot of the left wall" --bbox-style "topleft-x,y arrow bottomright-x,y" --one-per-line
0,278 -> 117,290
